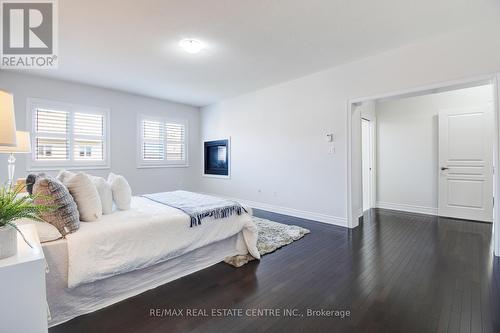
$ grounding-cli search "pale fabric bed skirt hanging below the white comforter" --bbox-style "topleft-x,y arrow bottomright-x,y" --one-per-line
43,232 -> 248,327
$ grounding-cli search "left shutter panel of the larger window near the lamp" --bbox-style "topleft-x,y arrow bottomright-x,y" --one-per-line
34,108 -> 69,161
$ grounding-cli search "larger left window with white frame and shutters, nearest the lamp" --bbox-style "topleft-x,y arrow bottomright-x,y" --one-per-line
28,99 -> 109,169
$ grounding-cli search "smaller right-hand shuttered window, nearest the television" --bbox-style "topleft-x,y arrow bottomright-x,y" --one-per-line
139,116 -> 188,167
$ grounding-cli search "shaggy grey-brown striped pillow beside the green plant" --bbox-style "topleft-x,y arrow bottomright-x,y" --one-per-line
33,175 -> 80,236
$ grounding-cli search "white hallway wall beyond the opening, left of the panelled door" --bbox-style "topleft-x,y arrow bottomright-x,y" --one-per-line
376,85 -> 493,214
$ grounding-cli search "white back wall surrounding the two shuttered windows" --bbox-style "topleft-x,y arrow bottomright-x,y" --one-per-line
0,71 -> 201,194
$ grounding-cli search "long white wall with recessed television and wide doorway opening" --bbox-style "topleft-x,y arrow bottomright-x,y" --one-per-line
200,24 -> 500,225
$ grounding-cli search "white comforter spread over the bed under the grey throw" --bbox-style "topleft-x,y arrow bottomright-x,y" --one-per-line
66,197 -> 260,288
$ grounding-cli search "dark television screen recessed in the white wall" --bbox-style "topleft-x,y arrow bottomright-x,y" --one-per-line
204,139 -> 229,176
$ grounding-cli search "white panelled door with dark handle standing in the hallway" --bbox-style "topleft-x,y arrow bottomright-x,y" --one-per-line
438,105 -> 494,222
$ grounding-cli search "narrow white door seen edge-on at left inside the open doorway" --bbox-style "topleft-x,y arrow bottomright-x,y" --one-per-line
361,119 -> 372,211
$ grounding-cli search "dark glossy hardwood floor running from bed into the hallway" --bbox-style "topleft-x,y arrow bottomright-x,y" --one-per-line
50,210 -> 500,333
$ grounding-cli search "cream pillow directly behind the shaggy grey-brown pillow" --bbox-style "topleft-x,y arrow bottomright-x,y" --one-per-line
57,170 -> 102,222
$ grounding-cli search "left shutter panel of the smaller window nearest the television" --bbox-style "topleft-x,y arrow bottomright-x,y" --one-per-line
142,120 -> 165,161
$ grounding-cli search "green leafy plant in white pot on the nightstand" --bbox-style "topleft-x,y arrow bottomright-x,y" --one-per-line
0,186 -> 54,247
